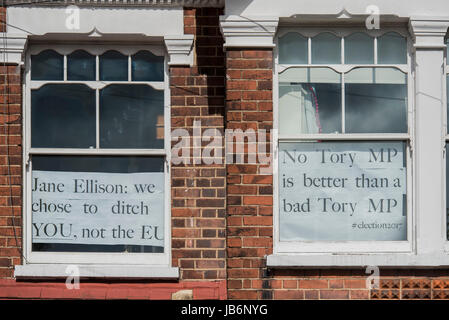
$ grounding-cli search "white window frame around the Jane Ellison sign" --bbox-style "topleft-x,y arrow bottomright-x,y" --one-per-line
22,43 -> 171,268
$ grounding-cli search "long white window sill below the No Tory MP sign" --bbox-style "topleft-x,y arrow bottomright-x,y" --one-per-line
267,253 -> 449,269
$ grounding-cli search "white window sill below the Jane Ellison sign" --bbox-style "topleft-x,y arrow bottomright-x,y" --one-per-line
14,264 -> 179,280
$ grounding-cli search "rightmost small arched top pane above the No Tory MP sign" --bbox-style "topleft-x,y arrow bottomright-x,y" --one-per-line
377,32 -> 407,64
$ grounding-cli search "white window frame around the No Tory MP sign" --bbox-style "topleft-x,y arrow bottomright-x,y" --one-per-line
273,26 -> 416,255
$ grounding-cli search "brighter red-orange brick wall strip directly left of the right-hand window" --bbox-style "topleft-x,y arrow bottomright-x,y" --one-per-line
226,49 -> 273,299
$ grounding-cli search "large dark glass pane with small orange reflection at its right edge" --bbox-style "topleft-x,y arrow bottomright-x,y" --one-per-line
100,84 -> 164,149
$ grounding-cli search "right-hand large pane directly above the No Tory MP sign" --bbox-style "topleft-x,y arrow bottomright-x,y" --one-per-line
345,68 -> 408,133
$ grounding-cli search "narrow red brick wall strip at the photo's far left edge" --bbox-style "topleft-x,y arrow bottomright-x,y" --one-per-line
0,64 -> 22,279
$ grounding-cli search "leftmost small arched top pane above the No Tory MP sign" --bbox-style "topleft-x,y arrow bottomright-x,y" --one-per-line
279,32 -> 309,64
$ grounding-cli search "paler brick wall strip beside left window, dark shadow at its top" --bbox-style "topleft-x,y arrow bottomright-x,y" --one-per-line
170,8 -> 226,280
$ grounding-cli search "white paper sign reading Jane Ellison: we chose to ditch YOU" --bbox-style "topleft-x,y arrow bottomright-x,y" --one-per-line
31,171 -> 164,246
